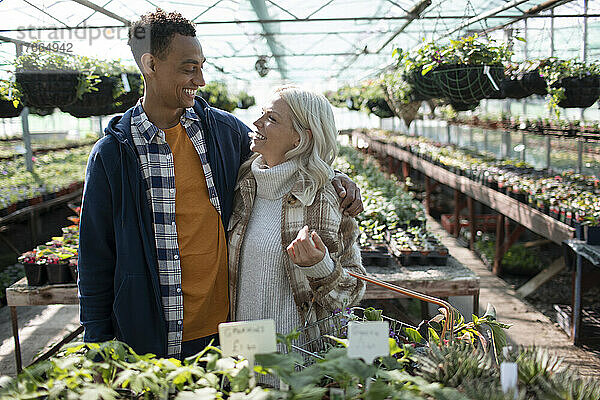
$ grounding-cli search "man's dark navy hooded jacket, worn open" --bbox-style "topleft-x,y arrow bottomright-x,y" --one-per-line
78,97 -> 251,357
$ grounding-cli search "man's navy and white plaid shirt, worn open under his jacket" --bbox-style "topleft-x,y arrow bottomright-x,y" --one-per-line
131,100 -> 221,357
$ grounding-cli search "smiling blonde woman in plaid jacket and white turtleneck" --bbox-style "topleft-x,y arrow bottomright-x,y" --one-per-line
228,86 -> 365,344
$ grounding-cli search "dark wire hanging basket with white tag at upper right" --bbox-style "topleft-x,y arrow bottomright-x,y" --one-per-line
433,64 -> 504,104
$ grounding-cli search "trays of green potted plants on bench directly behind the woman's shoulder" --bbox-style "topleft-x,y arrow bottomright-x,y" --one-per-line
335,146 -> 448,265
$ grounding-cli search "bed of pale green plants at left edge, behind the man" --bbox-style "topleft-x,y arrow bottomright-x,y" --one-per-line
0,145 -> 92,217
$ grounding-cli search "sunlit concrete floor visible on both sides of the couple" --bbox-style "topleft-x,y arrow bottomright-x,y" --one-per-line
0,218 -> 600,377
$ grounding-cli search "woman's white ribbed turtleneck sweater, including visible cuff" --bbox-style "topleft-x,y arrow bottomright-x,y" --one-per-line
236,156 -> 334,340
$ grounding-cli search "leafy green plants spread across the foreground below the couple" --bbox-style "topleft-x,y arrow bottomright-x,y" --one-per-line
0,307 -> 600,400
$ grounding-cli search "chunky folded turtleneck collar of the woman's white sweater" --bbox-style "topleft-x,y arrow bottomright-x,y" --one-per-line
251,156 -> 298,200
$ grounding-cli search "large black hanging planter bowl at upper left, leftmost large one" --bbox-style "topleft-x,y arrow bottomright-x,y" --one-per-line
15,71 -> 83,107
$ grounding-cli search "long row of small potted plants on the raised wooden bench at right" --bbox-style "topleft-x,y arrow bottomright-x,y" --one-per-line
360,130 -> 600,231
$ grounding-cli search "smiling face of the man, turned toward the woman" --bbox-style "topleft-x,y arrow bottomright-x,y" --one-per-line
154,34 -> 205,109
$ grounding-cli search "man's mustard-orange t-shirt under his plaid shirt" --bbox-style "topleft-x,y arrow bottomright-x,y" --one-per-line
164,123 -> 229,341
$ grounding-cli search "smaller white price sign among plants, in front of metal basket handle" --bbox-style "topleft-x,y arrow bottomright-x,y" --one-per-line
348,321 -> 390,364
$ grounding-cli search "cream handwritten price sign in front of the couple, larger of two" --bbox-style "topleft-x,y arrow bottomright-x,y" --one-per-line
219,319 -> 277,364
